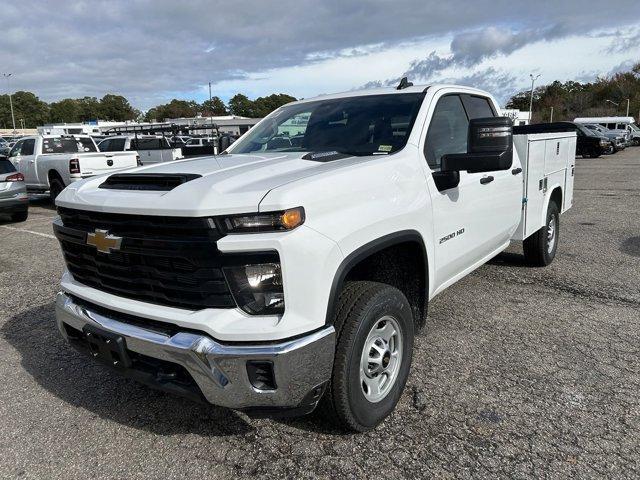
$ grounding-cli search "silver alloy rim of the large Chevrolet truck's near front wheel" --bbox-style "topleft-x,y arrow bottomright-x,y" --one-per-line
360,315 -> 402,403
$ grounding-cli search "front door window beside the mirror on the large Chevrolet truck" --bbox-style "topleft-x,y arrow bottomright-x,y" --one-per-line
424,95 -> 469,169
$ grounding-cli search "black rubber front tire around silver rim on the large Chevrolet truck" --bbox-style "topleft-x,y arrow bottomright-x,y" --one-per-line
319,282 -> 414,432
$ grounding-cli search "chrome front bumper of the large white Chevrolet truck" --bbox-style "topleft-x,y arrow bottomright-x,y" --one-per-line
56,293 -> 335,414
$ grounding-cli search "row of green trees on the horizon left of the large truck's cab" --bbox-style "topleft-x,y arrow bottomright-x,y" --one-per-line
0,91 -> 296,129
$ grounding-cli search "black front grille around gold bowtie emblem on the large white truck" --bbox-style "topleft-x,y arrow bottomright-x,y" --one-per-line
54,208 -> 278,310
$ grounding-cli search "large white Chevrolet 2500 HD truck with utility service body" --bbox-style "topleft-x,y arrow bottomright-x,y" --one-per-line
54,82 -> 576,431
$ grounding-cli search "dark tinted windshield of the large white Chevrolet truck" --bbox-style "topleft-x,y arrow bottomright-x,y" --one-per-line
230,92 -> 424,155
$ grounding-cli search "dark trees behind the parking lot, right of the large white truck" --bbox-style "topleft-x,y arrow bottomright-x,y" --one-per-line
506,63 -> 640,123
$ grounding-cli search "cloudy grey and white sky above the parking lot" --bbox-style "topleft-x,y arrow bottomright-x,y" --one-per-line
0,0 -> 640,109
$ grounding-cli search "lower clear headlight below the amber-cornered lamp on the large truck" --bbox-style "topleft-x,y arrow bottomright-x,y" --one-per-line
224,263 -> 284,315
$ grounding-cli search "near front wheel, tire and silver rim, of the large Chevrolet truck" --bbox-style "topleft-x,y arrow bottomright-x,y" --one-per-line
320,282 -> 414,432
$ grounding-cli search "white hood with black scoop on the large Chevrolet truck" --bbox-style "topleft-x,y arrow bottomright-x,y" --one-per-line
56,152 -> 362,217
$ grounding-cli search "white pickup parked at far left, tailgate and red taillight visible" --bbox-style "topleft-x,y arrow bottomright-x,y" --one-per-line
9,135 -> 139,199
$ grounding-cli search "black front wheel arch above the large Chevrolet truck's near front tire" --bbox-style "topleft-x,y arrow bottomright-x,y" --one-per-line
325,230 -> 429,329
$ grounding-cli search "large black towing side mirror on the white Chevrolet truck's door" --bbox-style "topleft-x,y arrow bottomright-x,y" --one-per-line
440,117 -> 513,173
